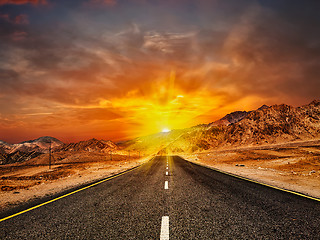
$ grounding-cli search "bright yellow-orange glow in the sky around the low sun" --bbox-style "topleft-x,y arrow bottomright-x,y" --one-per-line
107,71 -> 225,138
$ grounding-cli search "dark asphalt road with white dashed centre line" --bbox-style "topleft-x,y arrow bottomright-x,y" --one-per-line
0,157 -> 320,239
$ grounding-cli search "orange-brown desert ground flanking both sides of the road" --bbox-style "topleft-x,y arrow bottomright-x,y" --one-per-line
0,140 -> 320,210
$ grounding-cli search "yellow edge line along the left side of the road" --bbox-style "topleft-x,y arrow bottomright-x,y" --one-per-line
0,160 -> 149,222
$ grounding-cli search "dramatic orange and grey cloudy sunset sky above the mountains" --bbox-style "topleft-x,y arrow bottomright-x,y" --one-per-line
0,0 -> 320,143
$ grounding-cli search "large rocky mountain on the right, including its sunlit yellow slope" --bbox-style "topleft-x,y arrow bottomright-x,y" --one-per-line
127,101 -> 320,153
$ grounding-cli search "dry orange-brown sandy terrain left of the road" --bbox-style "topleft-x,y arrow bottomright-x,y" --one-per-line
0,153 -> 151,210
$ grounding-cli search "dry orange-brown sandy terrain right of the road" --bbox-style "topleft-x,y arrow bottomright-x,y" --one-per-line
181,141 -> 320,198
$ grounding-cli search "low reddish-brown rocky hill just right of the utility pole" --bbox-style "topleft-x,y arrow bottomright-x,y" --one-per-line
55,138 -> 118,153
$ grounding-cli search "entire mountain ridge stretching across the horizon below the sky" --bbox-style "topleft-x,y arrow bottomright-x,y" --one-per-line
0,100 -> 320,162
